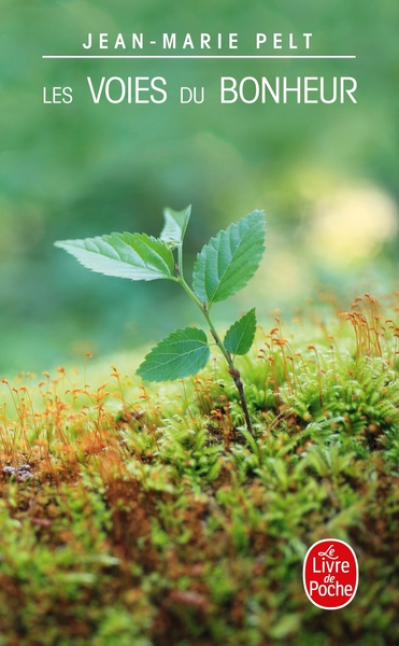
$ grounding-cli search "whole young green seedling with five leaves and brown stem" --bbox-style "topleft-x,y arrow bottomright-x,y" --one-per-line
55,206 -> 265,435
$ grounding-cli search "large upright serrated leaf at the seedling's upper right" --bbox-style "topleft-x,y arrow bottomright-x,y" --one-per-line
193,211 -> 265,309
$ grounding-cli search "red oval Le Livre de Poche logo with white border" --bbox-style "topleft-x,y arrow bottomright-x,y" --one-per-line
303,538 -> 359,610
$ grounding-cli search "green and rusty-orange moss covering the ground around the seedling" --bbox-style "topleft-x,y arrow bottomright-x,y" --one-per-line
0,296 -> 399,646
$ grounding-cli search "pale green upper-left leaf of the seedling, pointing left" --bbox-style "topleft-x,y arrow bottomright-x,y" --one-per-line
55,233 -> 174,280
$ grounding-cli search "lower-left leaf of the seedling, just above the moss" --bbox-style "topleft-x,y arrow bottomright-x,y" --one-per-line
137,327 -> 210,381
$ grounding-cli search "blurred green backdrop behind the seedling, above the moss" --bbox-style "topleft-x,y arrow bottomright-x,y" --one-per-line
0,0 -> 399,374
